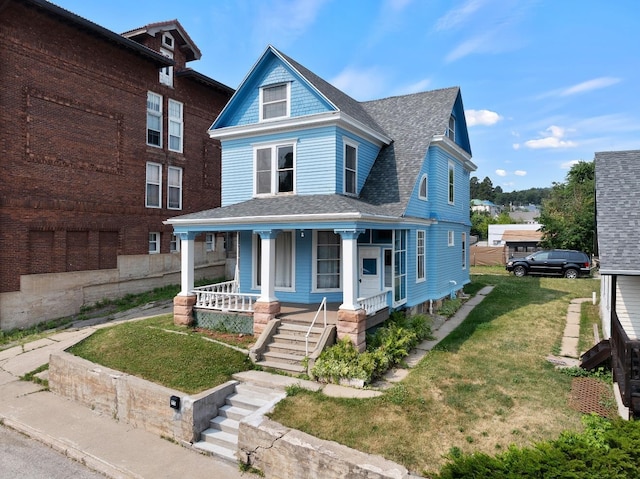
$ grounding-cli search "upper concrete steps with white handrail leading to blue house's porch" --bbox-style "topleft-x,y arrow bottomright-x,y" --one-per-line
256,317 -> 324,375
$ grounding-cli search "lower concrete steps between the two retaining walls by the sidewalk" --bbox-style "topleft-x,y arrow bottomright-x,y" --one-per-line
193,383 -> 284,463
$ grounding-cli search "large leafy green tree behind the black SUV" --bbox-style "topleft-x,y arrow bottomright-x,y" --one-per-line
538,161 -> 596,253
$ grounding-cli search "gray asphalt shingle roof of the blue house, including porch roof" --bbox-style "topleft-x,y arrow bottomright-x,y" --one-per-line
168,47 -> 460,225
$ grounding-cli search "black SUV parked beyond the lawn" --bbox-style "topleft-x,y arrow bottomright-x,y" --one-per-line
507,249 -> 591,279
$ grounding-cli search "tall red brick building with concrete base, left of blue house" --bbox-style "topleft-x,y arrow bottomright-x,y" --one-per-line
0,0 -> 233,330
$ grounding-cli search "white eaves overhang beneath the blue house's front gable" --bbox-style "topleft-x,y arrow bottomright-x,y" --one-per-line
209,111 -> 392,146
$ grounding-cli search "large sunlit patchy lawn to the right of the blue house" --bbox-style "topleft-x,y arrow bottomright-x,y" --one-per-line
272,269 -> 599,474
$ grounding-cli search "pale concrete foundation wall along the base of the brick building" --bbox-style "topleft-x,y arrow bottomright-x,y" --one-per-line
0,248 -> 228,331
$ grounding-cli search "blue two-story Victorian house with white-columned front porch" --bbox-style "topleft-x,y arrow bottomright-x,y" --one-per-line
167,46 -> 476,370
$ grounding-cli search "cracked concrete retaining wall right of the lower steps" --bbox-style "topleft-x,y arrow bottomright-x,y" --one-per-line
238,414 -> 417,479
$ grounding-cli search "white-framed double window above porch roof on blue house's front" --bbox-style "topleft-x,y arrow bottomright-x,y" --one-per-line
254,144 -> 295,195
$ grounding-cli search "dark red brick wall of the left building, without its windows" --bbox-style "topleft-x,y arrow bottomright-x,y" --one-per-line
0,1 -> 230,292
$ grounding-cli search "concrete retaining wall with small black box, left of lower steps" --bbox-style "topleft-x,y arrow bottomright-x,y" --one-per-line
49,352 -> 237,444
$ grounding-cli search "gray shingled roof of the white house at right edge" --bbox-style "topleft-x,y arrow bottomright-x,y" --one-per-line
595,150 -> 640,275
